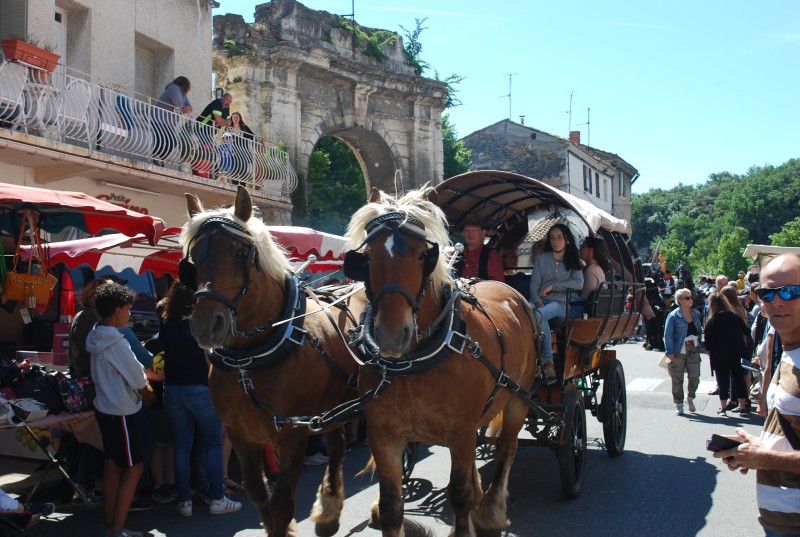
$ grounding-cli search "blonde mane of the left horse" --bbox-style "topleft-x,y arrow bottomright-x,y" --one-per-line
180,203 -> 291,281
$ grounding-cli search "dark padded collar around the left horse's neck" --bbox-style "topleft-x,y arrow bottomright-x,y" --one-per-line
208,272 -> 308,371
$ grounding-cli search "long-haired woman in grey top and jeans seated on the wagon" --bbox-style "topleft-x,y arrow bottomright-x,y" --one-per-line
530,224 -> 583,385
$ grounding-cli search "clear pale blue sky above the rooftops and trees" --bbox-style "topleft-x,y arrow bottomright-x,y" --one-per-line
214,0 -> 800,192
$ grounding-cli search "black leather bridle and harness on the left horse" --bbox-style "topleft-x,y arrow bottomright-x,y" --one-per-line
178,217 -> 360,429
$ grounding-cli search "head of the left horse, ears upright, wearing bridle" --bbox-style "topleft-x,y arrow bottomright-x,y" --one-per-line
179,186 -> 289,349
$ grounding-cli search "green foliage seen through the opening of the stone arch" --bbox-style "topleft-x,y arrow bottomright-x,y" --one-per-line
308,136 -> 367,235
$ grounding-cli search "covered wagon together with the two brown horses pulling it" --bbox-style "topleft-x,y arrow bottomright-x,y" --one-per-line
180,172 -> 644,537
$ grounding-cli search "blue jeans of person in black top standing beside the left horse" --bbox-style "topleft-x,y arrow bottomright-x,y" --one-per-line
164,384 -> 223,502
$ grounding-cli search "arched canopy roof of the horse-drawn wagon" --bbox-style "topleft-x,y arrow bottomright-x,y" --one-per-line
429,170 -> 631,248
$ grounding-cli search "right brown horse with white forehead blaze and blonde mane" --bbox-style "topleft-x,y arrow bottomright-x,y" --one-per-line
345,191 -> 537,537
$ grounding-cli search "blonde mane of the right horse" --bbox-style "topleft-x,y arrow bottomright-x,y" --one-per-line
345,187 -> 453,293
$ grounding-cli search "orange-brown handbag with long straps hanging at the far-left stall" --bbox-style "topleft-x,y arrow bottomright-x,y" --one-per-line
3,209 -> 58,308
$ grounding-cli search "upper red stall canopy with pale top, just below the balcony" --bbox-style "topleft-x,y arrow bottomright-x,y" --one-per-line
0,183 -> 166,244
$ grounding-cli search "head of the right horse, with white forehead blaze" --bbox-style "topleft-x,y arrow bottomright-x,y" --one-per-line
344,190 -> 451,358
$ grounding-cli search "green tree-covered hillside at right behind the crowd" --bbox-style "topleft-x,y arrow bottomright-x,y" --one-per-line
631,159 -> 800,274
